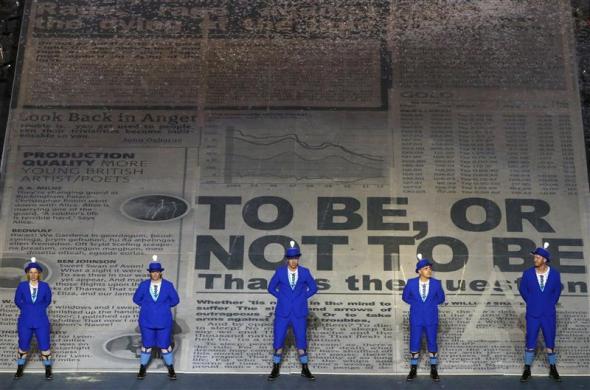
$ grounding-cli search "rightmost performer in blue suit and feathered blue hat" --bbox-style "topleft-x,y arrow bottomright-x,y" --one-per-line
518,242 -> 561,382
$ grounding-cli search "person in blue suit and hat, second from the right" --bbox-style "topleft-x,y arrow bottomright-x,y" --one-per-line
402,254 -> 445,382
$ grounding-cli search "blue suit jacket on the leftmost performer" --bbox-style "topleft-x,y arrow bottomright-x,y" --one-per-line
14,281 -> 51,328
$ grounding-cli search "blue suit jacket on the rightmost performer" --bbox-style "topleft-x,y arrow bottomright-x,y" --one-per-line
518,267 -> 561,317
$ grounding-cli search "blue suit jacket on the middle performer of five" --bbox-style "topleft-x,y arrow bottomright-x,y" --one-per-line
268,265 -> 318,317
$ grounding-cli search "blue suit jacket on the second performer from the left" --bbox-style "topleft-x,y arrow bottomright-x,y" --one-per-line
133,279 -> 180,329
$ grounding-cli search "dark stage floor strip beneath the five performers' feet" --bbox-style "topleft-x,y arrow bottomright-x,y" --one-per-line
0,372 -> 590,390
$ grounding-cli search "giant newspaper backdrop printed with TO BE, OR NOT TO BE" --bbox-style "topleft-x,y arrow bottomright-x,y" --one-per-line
0,0 -> 590,374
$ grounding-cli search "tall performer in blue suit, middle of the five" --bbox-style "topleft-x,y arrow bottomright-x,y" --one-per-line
268,241 -> 318,380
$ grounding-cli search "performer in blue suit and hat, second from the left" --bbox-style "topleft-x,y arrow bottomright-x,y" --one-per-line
133,255 -> 180,379
